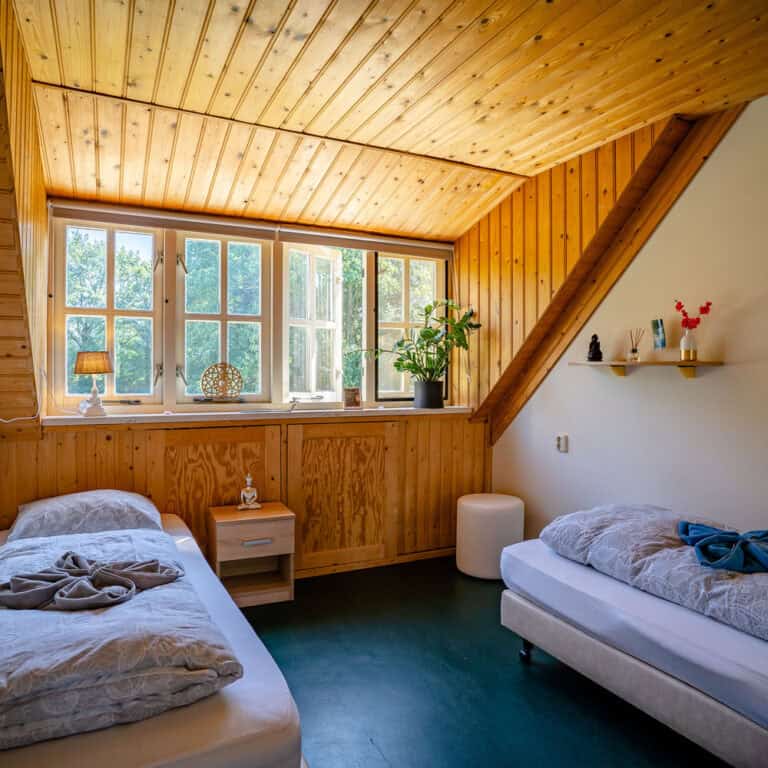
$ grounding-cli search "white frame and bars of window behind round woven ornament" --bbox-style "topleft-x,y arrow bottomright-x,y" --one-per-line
174,231 -> 272,408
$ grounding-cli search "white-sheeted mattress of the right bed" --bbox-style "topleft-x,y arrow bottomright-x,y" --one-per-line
501,539 -> 768,728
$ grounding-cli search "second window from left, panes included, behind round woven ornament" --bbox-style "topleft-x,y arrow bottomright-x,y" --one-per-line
176,232 -> 270,402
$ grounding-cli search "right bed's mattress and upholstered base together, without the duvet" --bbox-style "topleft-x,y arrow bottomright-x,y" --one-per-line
501,539 -> 768,768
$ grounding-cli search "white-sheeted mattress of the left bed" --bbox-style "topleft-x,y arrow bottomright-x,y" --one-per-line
0,515 -> 301,768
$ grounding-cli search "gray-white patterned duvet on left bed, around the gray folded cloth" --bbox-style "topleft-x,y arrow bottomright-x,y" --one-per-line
0,529 -> 243,748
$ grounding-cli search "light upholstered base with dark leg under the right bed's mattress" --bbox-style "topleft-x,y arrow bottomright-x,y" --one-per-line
501,589 -> 768,768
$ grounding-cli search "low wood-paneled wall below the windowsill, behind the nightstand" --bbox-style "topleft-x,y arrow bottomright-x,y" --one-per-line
0,413 -> 490,575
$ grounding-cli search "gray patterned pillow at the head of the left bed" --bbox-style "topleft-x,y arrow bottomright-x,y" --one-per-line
8,491 -> 163,541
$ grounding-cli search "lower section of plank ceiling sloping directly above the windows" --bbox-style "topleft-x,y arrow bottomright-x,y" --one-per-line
34,84 -> 525,239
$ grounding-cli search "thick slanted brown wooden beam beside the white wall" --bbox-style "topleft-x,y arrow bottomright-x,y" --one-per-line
473,105 -> 744,444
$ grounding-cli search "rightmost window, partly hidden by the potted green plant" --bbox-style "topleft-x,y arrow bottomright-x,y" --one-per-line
375,252 -> 447,400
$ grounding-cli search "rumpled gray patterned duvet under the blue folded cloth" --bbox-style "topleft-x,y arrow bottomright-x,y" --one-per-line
541,505 -> 768,640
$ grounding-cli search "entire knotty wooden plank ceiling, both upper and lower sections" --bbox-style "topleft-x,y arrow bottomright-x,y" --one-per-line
14,0 -> 768,239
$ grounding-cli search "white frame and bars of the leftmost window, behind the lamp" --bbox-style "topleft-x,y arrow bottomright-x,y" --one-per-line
49,219 -> 164,411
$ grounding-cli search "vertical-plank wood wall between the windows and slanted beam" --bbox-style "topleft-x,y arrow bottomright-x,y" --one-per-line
451,121 -> 667,406
